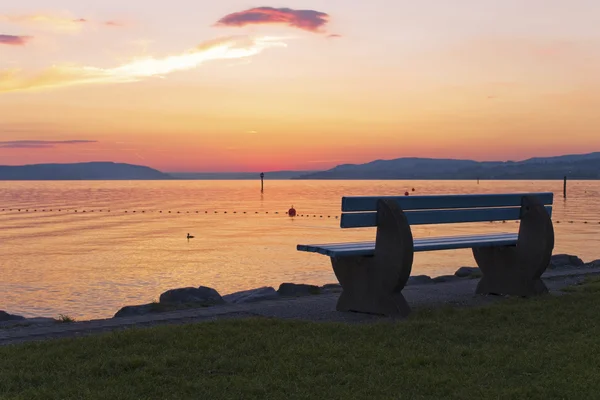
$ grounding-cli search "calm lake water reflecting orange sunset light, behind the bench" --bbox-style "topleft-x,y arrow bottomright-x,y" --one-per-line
0,181 -> 600,319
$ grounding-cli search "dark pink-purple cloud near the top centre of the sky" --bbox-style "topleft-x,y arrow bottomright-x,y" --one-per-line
216,7 -> 329,33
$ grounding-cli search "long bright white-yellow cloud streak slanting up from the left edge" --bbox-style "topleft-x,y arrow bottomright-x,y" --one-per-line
0,36 -> 286,93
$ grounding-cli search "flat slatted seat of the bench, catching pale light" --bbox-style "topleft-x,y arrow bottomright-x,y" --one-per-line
297,233 -> 519,257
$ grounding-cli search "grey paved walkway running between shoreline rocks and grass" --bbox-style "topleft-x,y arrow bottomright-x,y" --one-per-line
0,268 -> 600,346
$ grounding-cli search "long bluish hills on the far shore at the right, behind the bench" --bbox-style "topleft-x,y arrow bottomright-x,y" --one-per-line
293,152 -> 600,180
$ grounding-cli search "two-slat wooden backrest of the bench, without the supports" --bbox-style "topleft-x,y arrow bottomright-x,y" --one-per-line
340,193 -> 554,228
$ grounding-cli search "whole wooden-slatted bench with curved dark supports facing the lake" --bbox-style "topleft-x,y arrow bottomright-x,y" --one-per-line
297,193 -> 554,316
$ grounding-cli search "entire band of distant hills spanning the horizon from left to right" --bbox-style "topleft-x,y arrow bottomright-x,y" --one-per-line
0,152 -> 600,180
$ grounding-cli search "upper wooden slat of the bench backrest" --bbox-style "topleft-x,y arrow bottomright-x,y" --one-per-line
342,192 -> 554,211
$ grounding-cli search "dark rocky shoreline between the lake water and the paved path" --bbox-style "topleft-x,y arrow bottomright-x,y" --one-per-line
0,254 -> 600,336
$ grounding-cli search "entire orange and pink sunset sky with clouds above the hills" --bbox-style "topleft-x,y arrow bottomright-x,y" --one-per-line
0,0 -> 600,172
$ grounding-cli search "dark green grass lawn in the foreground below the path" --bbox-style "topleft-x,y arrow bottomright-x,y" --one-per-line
0,280 -> 600,400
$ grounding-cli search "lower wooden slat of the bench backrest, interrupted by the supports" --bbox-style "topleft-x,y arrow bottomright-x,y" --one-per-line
340,206 -> 552,228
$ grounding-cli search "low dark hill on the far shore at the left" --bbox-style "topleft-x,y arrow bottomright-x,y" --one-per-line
0,162 -> 173,181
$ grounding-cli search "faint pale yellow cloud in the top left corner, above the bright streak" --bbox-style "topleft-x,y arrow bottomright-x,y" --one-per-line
0,14 -> 123,33
